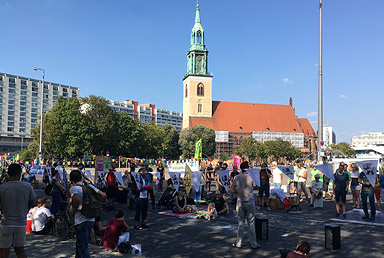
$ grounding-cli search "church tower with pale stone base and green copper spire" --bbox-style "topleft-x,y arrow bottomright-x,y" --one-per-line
183,4 -> 212,129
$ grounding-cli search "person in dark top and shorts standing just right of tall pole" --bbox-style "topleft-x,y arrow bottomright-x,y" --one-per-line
333,164 -> 349,218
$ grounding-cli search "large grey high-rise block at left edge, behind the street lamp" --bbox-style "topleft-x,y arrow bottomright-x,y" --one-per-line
0,73 -> 79,153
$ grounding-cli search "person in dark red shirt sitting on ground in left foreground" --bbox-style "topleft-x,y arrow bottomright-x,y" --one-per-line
103,209 -> 133,250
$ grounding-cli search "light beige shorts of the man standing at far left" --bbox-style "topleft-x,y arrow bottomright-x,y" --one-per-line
0,226 -> 26,248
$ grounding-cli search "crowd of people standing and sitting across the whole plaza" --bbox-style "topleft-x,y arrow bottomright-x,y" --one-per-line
0,157 -> 384,257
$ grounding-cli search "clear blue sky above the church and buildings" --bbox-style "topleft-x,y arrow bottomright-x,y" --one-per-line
0,0 -> 384,142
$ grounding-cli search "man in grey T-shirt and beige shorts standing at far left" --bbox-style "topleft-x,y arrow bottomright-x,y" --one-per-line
0,163 -> 36,258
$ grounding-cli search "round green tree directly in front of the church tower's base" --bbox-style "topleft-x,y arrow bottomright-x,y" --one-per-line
179,125 -> 216,158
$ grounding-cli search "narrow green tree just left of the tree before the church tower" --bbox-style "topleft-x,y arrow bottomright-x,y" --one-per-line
161,124 -> 181,159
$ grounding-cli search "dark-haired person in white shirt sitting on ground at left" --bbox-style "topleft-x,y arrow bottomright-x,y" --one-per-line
32,197 -> 53,235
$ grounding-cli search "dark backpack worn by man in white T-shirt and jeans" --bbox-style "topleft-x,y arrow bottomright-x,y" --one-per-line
80,185 -> 103,219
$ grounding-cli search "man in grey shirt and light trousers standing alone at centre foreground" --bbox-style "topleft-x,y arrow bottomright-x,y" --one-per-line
231,166 -> 260,249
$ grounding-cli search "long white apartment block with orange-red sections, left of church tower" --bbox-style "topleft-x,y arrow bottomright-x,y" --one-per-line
109,100 -> 183,132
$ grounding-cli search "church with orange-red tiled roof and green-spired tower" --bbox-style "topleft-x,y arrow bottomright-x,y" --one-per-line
183,4 -> 317,158
